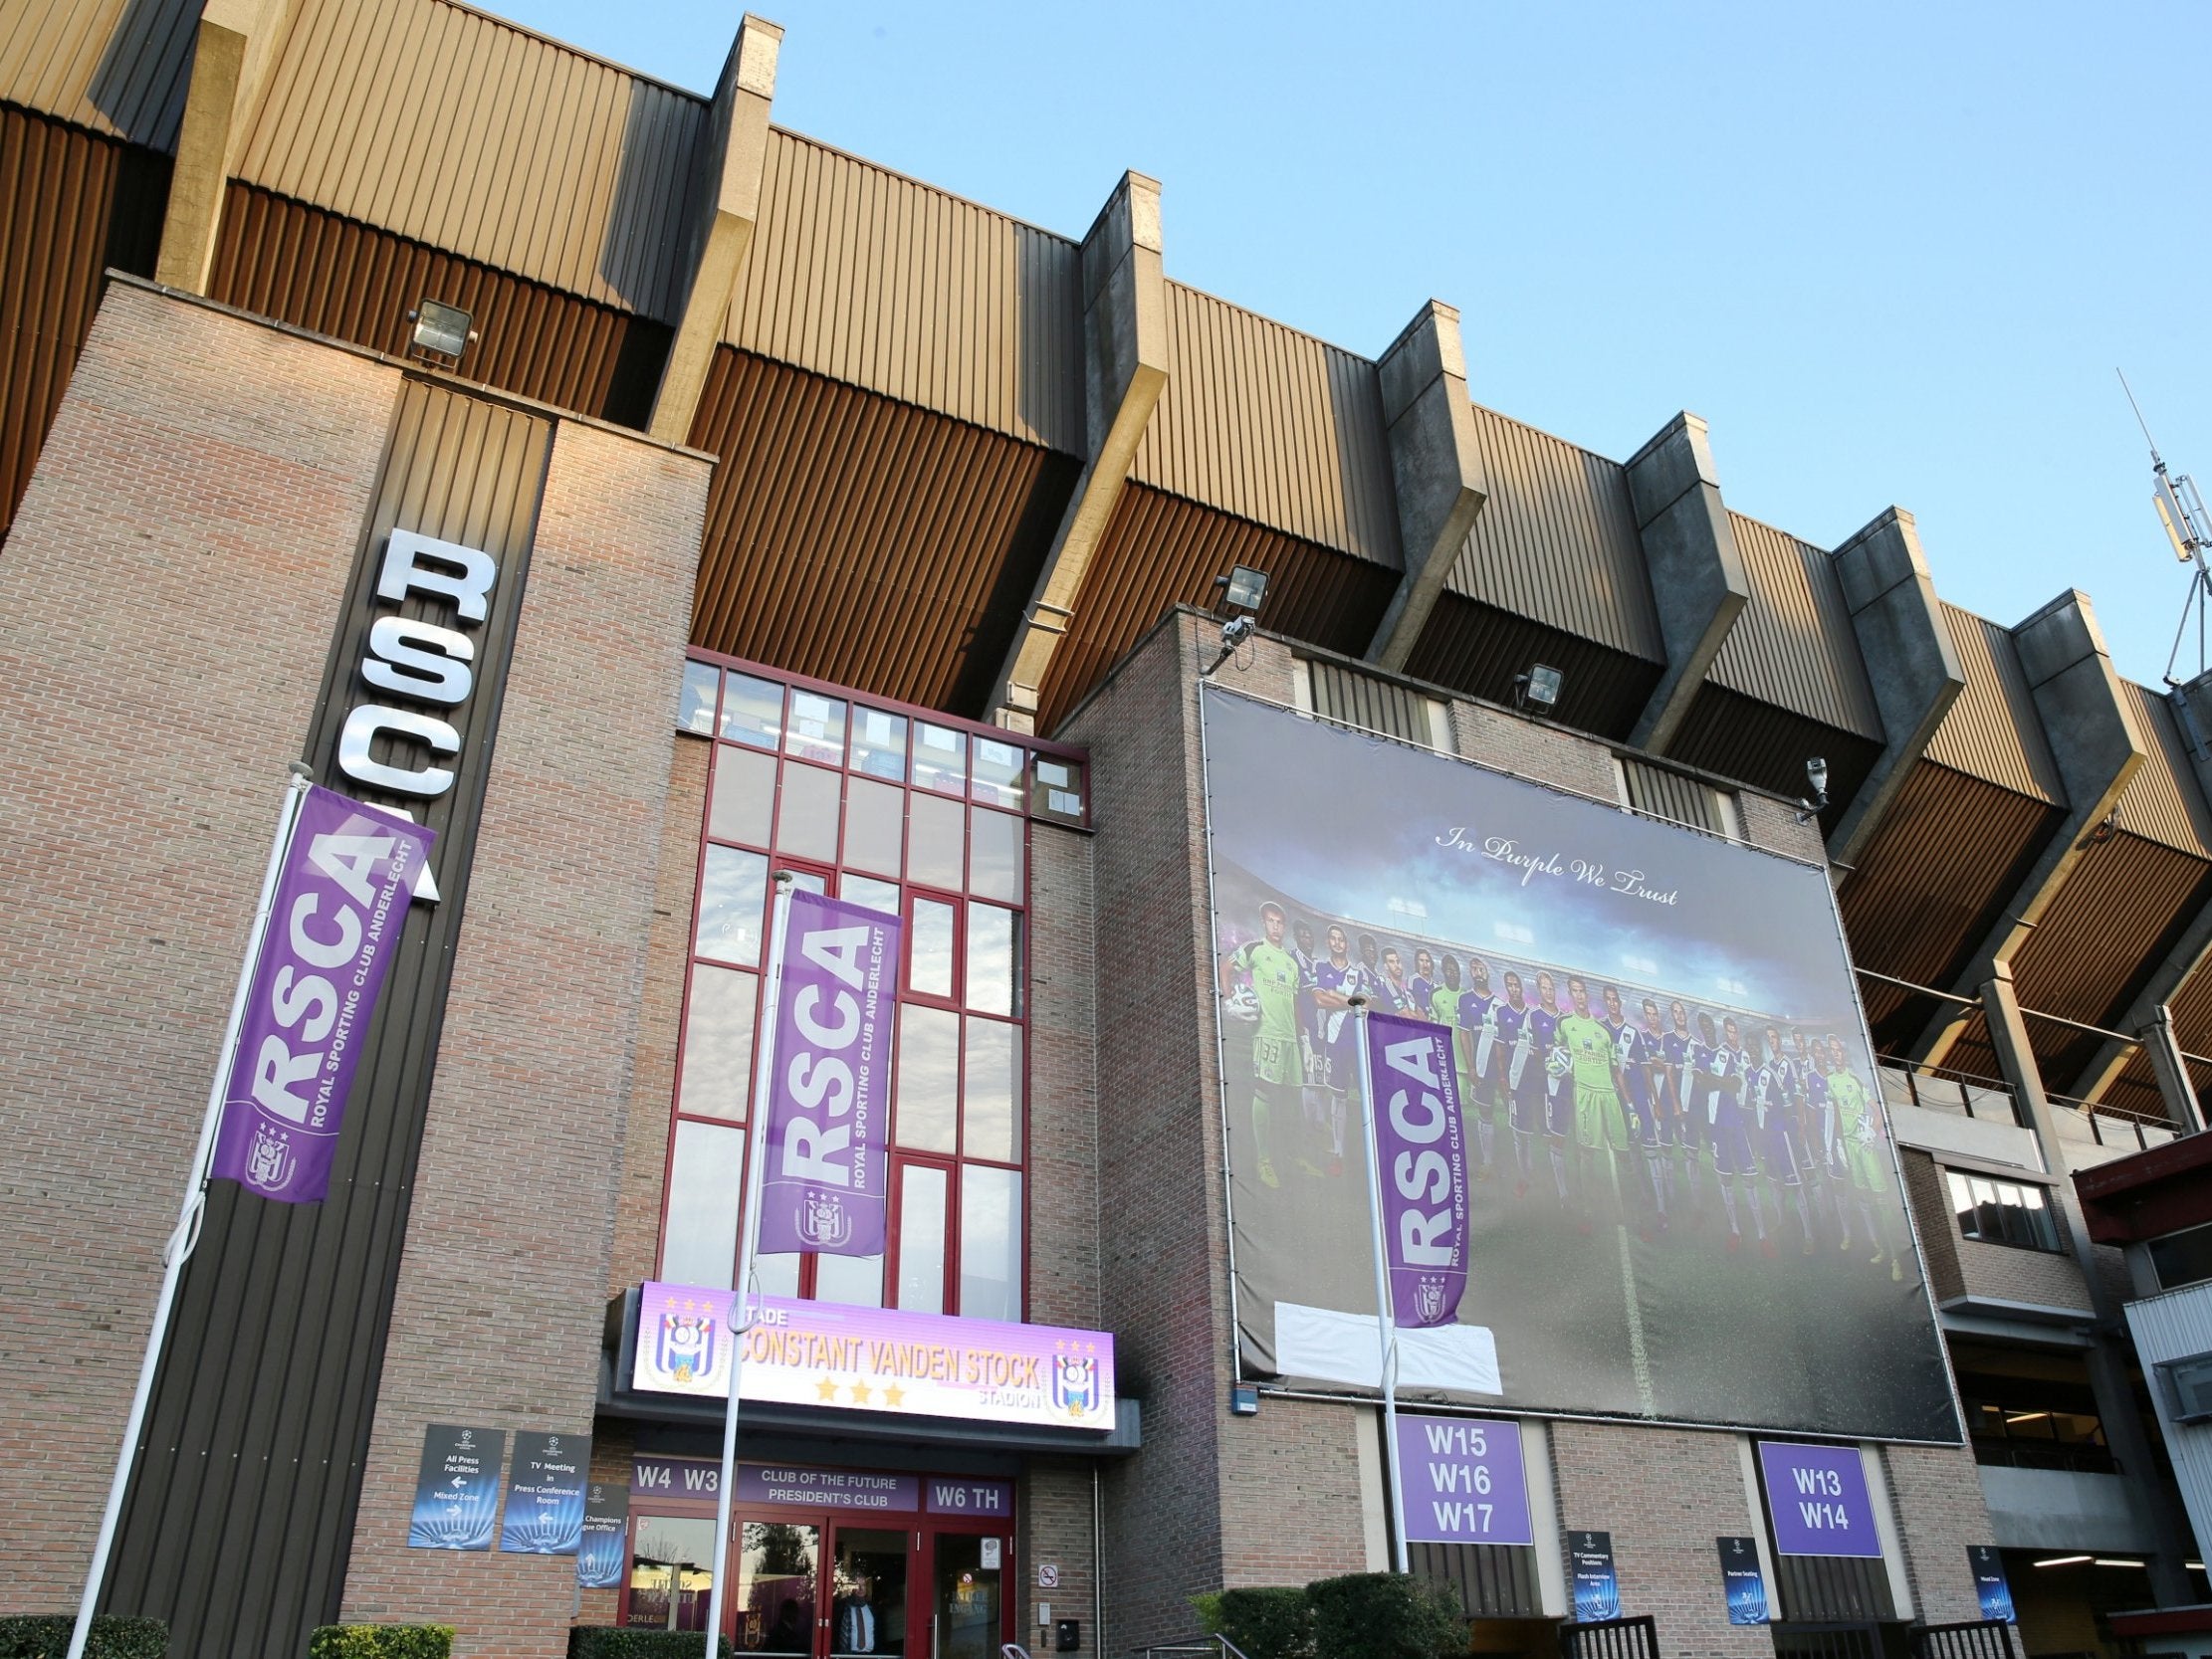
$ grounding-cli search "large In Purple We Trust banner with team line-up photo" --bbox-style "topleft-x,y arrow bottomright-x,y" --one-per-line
1202,686 -> 1960,1442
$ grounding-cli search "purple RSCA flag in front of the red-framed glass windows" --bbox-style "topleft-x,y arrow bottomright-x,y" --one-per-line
761,892 -> 898,1256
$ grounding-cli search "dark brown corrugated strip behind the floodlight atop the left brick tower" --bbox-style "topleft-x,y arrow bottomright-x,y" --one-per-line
208,181 -> 670,427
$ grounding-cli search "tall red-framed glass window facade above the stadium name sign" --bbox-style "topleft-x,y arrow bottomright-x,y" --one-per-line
659,662 -> 1084,1321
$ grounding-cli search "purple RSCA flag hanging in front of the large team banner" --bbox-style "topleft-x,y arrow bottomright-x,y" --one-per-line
1367,1013 -> 1466,1328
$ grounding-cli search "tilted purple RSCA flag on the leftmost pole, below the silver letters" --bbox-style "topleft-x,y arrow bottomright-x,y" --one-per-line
210,789 -> 438,1203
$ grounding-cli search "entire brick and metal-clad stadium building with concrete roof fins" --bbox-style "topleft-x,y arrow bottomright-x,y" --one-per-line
0,0 -> 2212,1659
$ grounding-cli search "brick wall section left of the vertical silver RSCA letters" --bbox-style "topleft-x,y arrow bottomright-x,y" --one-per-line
0,284 -> 400,1612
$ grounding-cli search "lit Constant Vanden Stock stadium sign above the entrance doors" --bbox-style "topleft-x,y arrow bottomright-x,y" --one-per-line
630,1283 -> 1115,1433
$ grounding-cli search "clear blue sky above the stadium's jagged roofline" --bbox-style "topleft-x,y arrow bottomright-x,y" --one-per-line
494,0 -> 2212,684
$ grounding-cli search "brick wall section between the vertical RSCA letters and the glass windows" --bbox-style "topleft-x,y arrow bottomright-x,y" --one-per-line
345,425 -> 706,1655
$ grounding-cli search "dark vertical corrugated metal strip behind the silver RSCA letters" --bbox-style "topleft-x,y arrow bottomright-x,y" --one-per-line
109,383 -> 553,1659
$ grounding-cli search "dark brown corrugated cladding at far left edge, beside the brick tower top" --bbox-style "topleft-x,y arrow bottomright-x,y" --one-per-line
0,106 -> 168,539
